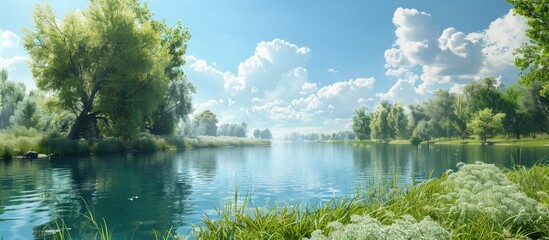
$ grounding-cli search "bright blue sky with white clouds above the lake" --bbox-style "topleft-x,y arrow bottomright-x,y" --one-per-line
0,0 -> 527,136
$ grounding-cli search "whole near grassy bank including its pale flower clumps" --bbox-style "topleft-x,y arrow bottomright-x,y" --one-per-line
197,163 -> 549,239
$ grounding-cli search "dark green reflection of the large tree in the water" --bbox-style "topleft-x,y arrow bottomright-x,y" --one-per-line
28,152 -> 195,239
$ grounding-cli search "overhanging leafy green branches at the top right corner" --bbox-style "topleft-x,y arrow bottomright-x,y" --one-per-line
507,0 -> 549,97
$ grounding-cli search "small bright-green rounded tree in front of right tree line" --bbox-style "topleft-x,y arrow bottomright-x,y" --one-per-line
467,108 -> 505,142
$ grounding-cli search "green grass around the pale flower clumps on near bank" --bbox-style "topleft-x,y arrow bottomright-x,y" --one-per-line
197,165 -> 549,239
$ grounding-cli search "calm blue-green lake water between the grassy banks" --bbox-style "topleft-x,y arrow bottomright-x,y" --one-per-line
0,143 -> 549,239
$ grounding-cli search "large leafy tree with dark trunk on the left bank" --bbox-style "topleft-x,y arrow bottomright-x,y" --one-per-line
24,0 -> 169,139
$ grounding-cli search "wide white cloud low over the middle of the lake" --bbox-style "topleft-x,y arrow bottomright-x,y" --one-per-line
185,39 -> 375,134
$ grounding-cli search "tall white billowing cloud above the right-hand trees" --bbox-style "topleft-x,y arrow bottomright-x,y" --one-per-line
378,8 -> 527,103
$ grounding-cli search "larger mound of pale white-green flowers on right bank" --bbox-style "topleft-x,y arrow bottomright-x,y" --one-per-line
437,162 -> 549,225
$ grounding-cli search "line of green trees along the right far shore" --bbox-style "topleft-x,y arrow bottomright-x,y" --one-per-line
353,78 -> 549,142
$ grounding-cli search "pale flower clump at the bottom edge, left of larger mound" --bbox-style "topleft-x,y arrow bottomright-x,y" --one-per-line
302,215 -> 450,240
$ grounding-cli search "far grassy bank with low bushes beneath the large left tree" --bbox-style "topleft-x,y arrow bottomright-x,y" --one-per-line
0,128 -> 271,159
